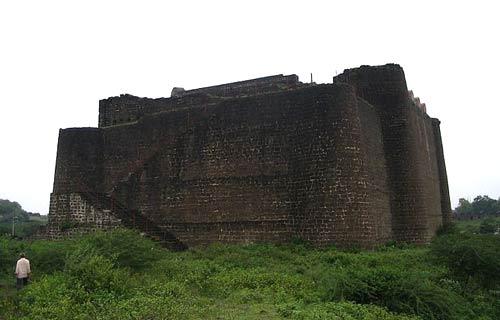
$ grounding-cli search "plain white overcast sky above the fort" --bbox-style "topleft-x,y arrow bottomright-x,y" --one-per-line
0,0 -> 500,214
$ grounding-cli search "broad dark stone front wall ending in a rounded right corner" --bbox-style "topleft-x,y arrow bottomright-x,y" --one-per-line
104,85 -> 375,245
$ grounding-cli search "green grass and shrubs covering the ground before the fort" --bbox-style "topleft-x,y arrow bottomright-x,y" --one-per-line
0,225 -> 500,320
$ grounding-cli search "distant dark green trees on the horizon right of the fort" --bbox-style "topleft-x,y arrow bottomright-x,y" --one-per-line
455,195 -> 500,218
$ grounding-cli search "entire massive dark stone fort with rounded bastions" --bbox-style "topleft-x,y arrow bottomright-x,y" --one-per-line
46,64 -> 451,249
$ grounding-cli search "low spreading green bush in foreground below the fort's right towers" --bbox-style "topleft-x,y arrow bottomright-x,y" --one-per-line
320,265 -> 464,319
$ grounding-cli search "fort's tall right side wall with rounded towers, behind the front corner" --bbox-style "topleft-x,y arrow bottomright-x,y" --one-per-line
334,65 -> 447,242
